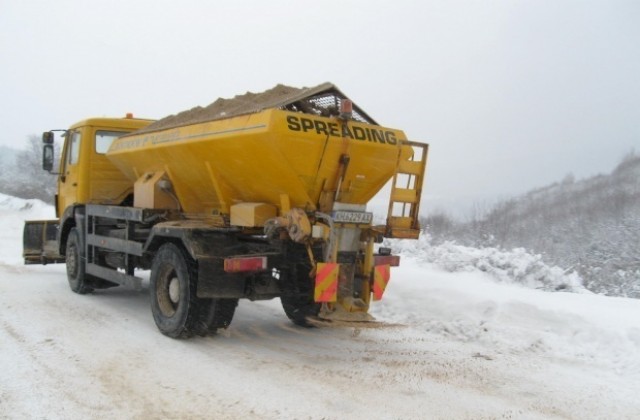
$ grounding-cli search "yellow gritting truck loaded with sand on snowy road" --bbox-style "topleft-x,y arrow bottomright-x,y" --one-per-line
24,83 -> 428,338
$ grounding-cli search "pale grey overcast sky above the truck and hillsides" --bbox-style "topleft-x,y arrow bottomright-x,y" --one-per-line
0,0 -> 640,217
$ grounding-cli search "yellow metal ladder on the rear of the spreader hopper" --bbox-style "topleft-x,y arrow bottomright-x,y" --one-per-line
384,141 -> 429,239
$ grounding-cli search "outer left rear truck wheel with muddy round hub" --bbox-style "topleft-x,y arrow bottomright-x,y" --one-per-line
149,243 -> 202,338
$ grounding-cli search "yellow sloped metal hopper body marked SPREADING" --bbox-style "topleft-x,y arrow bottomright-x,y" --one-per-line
108,109 -> 413,217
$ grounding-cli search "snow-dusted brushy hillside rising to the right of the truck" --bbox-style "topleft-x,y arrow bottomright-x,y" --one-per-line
427,153 -> 640,298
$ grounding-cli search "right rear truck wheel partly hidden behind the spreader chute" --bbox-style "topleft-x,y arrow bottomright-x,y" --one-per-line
280,264 -> 321,328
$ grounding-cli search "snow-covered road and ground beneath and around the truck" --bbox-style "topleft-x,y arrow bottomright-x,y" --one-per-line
0,195 -> 640,419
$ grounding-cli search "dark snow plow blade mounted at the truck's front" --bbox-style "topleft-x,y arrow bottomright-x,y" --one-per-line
22,220 -> 65,264
